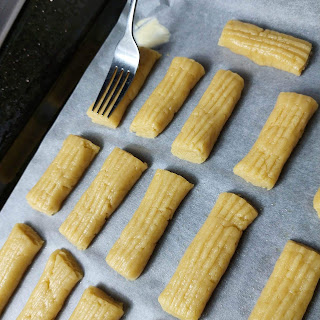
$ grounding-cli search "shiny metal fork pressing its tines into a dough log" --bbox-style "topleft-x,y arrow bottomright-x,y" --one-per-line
92,0 -> 140,117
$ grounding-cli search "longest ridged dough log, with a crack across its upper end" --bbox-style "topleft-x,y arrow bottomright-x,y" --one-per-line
159,193 -> 257,320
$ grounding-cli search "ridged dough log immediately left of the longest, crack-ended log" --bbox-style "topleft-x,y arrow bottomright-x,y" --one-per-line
106,170 -> 193,280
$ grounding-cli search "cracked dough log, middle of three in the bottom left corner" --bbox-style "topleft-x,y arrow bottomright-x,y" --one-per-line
17,249 -> 83,320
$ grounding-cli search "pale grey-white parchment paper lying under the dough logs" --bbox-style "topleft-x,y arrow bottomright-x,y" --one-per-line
0,0 -> 320,320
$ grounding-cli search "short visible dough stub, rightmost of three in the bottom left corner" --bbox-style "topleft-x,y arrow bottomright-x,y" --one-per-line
69,287 -> 123,320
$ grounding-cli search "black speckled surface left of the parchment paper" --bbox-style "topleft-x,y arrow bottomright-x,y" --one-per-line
0,0 -> 126,208
